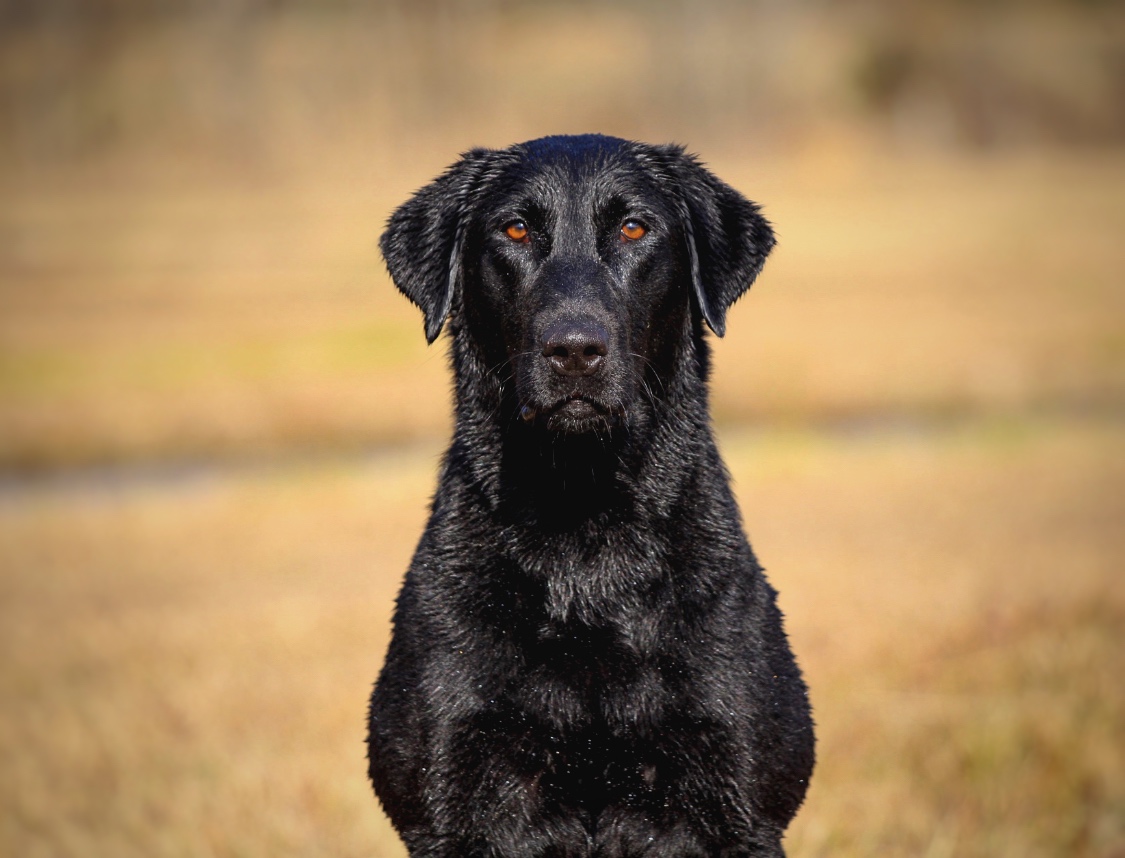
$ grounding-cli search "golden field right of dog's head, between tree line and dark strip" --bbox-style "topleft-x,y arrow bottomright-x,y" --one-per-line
716,151 -> 1125,427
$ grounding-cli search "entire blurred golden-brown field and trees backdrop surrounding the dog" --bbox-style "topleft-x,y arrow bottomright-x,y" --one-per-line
0,0 -> 1125,858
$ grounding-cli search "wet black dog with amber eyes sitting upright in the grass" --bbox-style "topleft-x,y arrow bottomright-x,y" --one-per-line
369,136 -> 813,858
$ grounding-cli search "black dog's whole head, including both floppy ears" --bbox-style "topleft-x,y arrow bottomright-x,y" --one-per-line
381,135 -> 774,434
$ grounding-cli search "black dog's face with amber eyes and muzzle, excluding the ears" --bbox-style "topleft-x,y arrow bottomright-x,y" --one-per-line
462,145 -> 689,433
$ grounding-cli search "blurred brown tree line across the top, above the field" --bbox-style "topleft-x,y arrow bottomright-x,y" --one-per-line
0,0 -> 1125,169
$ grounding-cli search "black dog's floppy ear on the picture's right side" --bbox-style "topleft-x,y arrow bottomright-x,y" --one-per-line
660,146 -> 775,336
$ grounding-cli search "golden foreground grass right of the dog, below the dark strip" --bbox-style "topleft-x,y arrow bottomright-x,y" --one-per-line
731,424 -> 1125,856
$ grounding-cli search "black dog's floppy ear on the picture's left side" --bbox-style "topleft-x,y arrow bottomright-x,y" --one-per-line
379,148 -> 492,343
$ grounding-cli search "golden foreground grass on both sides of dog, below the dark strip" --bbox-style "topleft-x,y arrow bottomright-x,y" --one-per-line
0,421 -> 1125,858
